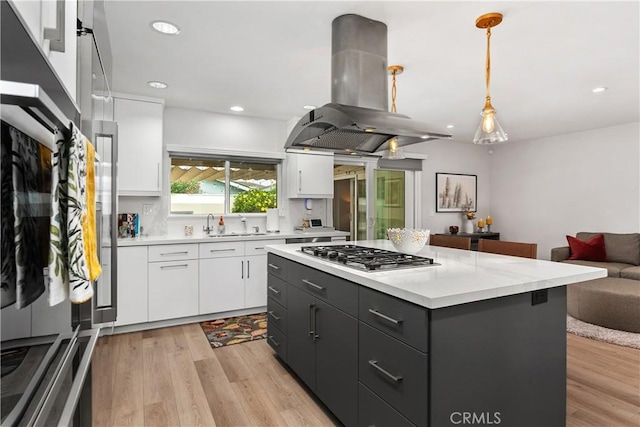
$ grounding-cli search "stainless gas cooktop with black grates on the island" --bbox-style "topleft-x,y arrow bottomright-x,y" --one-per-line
300,245 -> 438,271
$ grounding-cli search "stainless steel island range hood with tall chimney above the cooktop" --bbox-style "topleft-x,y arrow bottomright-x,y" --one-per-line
284,14 -> 451,154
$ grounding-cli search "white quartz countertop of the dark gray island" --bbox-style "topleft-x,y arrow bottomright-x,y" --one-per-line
266,240 -> 607,308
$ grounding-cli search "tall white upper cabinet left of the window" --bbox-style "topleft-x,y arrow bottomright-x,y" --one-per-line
114,97 -> 164,196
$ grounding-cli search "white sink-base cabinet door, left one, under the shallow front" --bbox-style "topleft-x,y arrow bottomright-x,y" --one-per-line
200,258 -> 245,314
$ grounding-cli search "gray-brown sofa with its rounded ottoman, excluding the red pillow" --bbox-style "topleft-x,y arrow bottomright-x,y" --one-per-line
551,232 -> 640,333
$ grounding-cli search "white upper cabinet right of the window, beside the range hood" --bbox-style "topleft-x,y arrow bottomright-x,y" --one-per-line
287,153 -> 333,199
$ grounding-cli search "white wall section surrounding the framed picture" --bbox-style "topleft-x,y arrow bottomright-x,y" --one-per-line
406,140 -> 494,234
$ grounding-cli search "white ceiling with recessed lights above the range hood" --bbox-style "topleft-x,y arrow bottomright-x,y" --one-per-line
105,0 -> 640,143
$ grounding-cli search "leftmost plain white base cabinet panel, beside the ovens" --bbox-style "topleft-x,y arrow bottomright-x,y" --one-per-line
115,246 -> 149,326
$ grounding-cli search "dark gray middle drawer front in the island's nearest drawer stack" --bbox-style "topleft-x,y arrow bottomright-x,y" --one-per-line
358,322 -> 428,426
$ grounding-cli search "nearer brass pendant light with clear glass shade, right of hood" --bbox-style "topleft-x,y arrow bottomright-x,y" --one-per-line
473,13 -> 509,144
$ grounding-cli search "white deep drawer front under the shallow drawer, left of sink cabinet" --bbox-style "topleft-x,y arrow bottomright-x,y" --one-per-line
149,260 -> 198,321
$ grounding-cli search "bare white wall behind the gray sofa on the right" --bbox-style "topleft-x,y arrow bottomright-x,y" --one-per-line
488,123 -> 640,259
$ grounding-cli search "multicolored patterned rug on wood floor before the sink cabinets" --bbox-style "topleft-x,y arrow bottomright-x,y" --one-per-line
200,313 -> 267,348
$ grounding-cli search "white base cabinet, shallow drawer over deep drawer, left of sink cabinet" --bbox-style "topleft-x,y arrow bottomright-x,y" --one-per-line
149,244 -> 198,322
